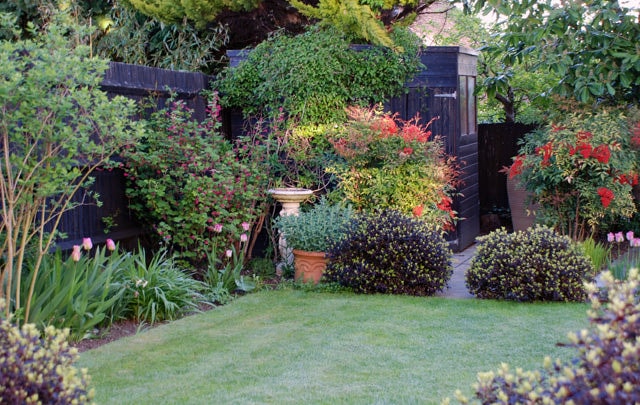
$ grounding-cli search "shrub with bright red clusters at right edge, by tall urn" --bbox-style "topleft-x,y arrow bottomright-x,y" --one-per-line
509,112 -> 638,239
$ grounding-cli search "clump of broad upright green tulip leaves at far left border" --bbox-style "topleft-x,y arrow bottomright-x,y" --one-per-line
17,240 -> 133,341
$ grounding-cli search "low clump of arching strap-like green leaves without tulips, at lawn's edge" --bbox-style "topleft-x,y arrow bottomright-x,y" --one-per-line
114,247 -> 203,324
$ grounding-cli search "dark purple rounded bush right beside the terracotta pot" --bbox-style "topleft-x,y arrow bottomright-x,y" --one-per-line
325,211 -> 453,296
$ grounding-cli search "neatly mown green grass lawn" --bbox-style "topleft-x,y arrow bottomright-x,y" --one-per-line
78,290 -> 588,404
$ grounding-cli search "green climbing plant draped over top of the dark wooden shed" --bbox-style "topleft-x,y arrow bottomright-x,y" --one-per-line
215,26 -> 421,124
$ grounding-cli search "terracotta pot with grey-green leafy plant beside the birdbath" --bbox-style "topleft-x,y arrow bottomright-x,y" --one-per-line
275,198 -> 353,283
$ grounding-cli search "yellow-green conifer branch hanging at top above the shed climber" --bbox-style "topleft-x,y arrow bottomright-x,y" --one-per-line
289,0 -> 394,48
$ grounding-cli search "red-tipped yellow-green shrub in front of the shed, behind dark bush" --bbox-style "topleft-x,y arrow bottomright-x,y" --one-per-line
329,106 -> 459,229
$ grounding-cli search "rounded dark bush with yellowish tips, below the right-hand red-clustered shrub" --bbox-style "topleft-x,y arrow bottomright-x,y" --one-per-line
466,226 -> 593,301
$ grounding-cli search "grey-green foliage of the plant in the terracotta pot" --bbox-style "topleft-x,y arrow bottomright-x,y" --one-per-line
274,198 -> 353,252
